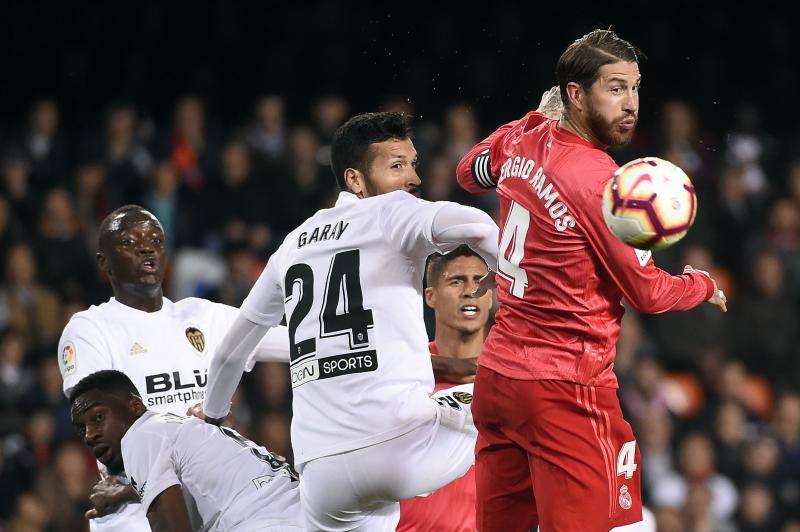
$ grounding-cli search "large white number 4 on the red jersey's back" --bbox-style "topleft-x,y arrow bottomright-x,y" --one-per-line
497,201 -> 531,299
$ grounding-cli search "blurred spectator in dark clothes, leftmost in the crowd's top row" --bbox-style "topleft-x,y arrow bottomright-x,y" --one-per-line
23,99 -> 69,193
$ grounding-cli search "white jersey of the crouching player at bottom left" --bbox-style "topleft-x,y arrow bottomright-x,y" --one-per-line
122,411 -> 303,531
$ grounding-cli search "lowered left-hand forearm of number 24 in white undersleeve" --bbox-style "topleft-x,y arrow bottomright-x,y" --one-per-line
203,314 -> 269,419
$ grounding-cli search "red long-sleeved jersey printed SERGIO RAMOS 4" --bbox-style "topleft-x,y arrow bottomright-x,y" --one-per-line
457,112 -> 714,387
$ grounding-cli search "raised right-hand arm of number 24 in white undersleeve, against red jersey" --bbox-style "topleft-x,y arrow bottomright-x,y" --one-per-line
431,203 -> 500,270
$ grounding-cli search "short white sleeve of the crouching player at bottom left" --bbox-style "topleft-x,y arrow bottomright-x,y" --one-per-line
122,423 -> 180,514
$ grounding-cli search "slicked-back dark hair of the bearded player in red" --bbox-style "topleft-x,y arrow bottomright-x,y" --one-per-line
556,29 -> 645,109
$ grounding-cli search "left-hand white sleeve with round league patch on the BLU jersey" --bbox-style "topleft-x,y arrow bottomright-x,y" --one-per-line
58,316 -> 113,397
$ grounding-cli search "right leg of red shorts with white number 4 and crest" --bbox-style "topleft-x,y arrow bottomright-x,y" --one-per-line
531,381 -> 641,532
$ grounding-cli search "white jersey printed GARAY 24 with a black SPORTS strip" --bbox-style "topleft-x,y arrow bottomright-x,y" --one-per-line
241,191 -> 466,464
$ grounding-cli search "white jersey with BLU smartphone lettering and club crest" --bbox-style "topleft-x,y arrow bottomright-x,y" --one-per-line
58,297 -> 289,415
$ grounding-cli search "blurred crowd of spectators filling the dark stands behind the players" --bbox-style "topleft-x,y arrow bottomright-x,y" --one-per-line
0,95 -> 800,532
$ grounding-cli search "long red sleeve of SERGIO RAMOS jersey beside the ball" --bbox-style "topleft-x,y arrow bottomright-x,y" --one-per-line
578,156 -> 714,314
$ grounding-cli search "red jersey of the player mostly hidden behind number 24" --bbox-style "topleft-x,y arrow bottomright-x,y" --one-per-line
396,342 -> 476,532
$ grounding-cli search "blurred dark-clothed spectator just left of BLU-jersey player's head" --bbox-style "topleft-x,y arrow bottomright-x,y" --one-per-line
35,188 -> 96,298
